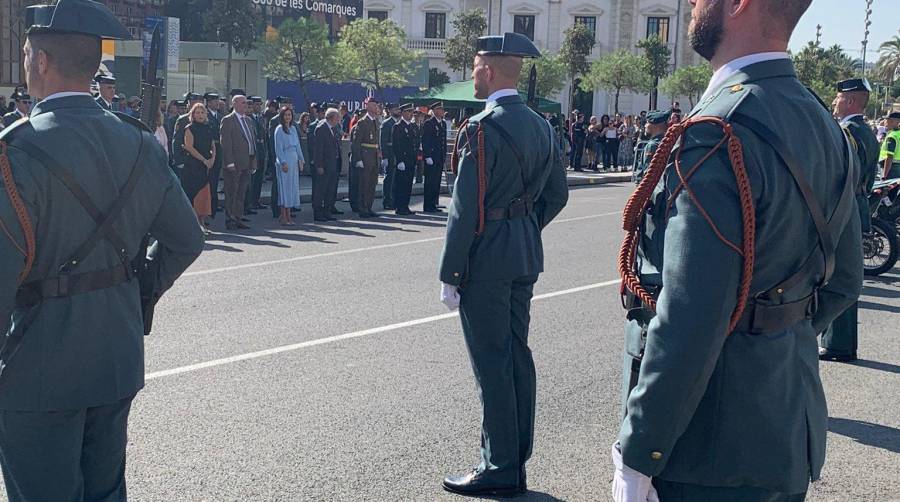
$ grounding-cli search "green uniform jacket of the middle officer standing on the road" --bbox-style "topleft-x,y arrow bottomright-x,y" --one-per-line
440,96 -> 569,285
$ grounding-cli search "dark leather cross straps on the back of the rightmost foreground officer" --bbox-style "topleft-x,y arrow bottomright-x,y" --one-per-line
731,112 -> 856,294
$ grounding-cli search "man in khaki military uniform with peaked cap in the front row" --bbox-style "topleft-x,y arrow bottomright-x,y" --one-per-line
350,96 -> 381,218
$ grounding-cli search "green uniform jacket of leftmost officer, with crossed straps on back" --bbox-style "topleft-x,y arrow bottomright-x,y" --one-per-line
0,96 -> 203,411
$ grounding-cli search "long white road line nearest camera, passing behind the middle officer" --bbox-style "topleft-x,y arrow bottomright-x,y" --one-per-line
144,279 -> 621,380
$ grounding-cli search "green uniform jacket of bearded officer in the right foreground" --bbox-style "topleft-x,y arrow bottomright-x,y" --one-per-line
619,59 -> 862,493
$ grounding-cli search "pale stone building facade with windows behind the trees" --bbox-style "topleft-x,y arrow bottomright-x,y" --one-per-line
364,0 -> 700,114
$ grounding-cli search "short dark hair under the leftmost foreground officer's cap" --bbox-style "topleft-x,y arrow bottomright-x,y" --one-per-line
28,32 -> 101,82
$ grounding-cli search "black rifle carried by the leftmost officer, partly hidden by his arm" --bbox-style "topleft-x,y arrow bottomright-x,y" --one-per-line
131,25 -> 162,336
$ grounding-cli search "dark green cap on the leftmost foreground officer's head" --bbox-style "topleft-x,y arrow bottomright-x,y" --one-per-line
25,0 -> 131,40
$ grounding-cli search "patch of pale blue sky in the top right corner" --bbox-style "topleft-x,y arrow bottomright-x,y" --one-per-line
790,0 -> 900,61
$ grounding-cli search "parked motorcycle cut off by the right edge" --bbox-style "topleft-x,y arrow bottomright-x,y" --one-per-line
863,178 -> 900,276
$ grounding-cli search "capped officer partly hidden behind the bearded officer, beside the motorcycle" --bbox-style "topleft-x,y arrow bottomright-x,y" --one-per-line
819,78 -> 878,361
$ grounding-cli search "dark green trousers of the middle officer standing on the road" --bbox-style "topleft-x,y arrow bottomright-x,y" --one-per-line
459,275 -> 537,485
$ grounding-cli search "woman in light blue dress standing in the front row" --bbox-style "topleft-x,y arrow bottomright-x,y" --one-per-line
275,106 -> 304,226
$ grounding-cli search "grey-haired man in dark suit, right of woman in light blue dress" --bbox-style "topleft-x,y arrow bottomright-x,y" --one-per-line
311,108 -> 341,221
